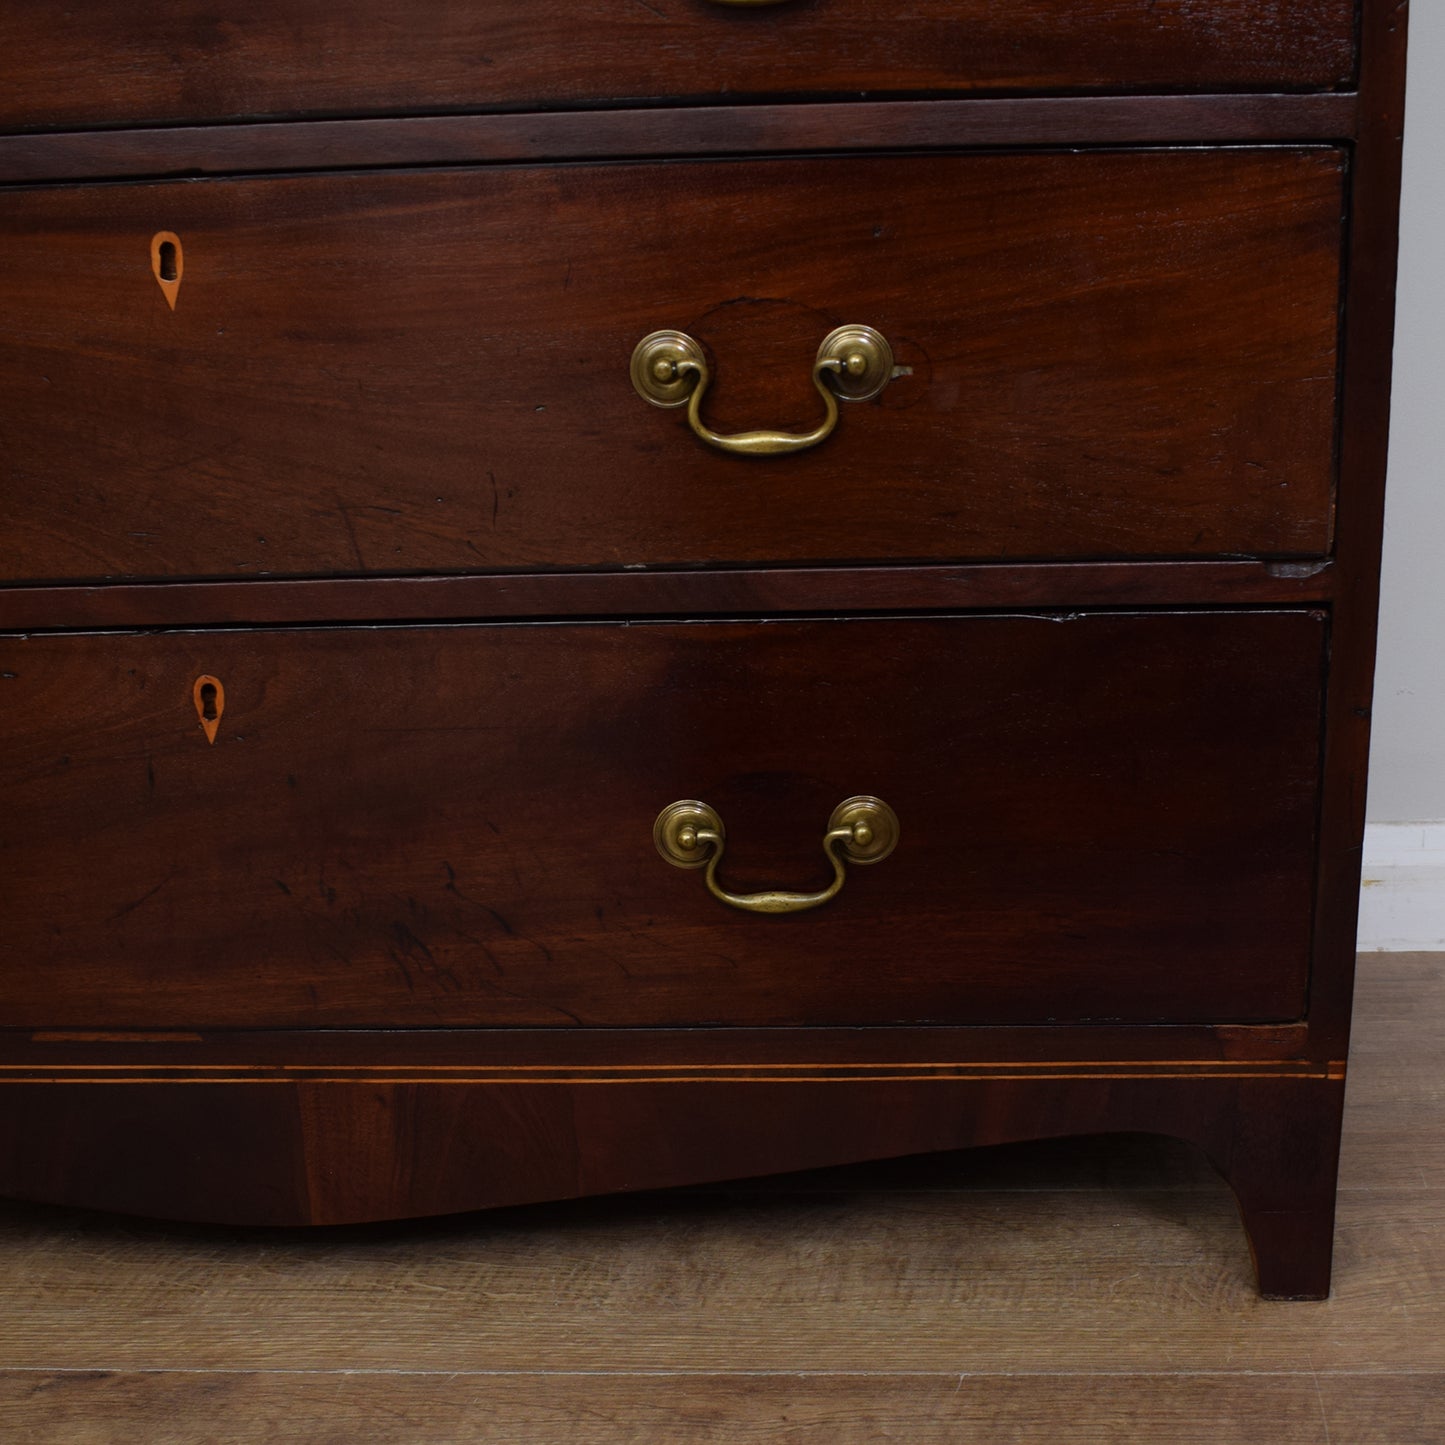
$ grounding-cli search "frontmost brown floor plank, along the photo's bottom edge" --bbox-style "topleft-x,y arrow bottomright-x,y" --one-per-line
0,1374 -> 1445,1445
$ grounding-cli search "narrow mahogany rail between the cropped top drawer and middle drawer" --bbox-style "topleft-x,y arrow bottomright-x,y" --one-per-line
0,91 -> 1360,184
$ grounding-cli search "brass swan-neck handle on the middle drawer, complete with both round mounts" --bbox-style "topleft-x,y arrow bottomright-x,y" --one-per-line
631,327 -> 893,457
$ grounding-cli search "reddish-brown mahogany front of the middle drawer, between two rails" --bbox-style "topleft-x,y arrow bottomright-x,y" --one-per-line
0,147 -> 1342,579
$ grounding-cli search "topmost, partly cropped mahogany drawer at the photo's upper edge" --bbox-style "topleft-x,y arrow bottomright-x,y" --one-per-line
0,0 -> 1355,129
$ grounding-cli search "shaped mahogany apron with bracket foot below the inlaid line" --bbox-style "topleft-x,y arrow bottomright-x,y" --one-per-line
0,1064 -> 1344,1299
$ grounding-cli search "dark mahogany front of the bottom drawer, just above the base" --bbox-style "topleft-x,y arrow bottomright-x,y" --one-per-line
0,611 -> 1325,1027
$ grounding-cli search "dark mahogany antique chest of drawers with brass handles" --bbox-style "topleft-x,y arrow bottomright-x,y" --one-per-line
0,0 -> 1405,1296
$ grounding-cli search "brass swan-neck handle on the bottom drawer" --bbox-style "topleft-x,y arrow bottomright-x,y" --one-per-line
652,795 -> 899,913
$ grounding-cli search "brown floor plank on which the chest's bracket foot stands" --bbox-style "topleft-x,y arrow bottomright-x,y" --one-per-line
0,1185 -> 1445,1373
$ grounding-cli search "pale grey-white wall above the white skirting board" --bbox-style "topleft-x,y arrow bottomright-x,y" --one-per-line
1367,0 -> 1445,826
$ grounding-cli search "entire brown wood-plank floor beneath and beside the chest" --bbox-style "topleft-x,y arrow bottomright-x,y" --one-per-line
0,954 -> 1445,1445
